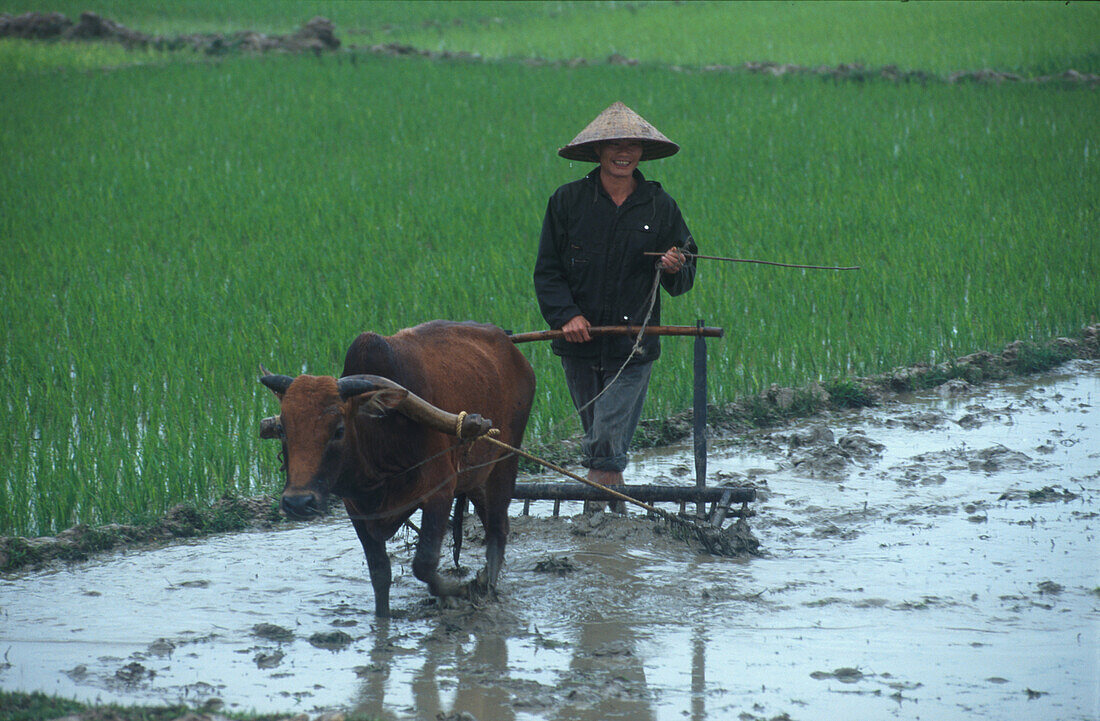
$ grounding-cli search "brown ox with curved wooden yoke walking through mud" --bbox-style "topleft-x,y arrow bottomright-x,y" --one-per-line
261,320 -> 535,615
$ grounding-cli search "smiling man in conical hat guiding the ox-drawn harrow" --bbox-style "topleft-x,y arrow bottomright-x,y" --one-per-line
535,102 -> 699,510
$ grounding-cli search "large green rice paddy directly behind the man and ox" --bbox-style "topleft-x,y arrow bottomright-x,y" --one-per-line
0,42 -> 1100,534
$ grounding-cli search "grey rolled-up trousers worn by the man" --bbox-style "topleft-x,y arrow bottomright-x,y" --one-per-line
561,356 -> 653,472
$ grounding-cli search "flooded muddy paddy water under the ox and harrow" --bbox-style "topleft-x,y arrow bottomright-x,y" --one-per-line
0,362 -> 1100,721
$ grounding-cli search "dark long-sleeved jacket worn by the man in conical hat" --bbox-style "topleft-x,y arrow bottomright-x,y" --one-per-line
535,167 -> 699,363
